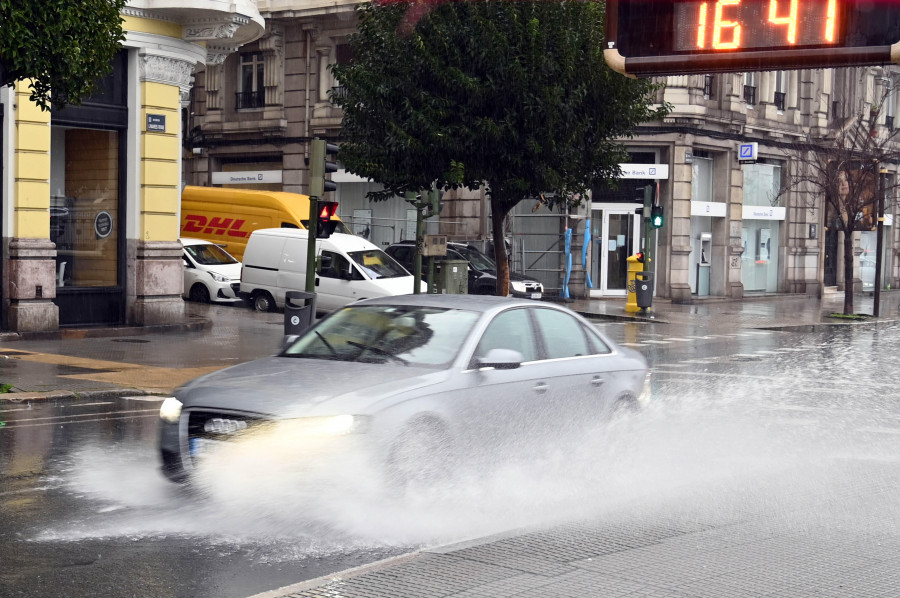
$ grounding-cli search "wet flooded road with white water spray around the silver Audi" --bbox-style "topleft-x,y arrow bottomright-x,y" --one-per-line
0,316 -> 900,597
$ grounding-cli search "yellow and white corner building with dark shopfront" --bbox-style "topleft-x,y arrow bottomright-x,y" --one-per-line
0,0 -> 264,332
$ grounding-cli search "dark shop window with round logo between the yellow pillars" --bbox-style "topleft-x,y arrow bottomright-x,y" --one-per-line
50,127 -> 120,287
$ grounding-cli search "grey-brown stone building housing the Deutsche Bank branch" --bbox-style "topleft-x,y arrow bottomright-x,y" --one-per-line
185,0 -> 900,302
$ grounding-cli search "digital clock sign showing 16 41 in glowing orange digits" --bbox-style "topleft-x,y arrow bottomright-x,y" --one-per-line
605,0 -> 900,76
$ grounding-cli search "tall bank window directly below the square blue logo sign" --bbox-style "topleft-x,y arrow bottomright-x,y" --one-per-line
741,164 -> 785,293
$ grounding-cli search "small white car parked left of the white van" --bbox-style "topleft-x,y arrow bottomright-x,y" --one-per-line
179,238 -> 242,303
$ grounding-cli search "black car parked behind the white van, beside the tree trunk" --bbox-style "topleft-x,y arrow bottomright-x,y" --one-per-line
384,241 -> 544,299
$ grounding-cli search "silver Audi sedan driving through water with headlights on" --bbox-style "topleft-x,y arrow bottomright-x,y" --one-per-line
159,294 -> 649,482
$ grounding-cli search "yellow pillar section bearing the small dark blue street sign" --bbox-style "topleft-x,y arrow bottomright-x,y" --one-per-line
140,82 -> 181,241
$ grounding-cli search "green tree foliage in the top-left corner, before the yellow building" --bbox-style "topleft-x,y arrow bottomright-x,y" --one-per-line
0,0 -> 126,110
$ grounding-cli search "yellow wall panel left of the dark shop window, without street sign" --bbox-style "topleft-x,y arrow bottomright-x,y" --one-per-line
12,81 -> 50,239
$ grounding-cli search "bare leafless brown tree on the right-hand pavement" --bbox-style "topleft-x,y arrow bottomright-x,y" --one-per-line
779,80 -> 900,315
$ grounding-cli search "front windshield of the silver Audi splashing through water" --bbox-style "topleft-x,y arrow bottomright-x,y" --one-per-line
281,305 -> 478,367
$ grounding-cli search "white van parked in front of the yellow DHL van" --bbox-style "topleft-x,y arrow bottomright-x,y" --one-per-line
241,228 -> 427,311
